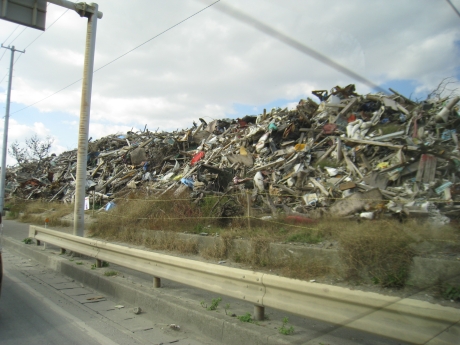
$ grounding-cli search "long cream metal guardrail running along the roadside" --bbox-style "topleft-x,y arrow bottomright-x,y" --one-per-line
29,226 -> 460,344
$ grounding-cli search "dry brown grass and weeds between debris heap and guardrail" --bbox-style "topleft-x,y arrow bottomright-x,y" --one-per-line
14,194 -> 460,287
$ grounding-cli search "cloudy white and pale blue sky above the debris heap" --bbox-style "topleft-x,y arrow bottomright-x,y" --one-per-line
0,0 -> 460,165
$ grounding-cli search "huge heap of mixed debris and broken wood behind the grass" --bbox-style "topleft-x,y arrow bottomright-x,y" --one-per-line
6,85 -> 460,223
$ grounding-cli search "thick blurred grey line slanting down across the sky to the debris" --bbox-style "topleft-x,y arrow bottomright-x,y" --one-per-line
210,3 -> 388,94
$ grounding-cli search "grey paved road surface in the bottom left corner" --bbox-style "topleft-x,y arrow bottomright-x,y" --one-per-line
0,250 -> 210,345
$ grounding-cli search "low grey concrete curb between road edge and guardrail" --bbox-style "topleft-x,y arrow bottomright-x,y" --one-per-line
3,237 -> 293,345
